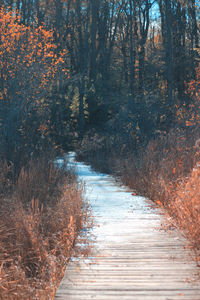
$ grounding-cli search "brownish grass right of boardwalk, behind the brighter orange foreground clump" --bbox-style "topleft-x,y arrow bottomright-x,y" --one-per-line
113,129 -> 197,206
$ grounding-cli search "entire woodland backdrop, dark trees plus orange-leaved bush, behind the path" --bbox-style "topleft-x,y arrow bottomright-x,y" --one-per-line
0,0 -> 200,168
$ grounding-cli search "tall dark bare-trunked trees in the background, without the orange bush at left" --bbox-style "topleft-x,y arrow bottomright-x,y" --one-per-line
0,0 -> 199,154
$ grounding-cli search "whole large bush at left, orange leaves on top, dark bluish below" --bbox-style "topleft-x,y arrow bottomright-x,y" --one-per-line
0,8 -> 69,170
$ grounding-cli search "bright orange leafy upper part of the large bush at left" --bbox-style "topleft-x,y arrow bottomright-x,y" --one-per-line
0,8 -> 68,105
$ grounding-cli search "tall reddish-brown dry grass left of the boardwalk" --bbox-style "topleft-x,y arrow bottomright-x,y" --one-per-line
0,158 -> 83,300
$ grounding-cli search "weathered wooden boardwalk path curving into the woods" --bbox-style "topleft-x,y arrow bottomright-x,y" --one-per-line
55,154 -> 200,300
